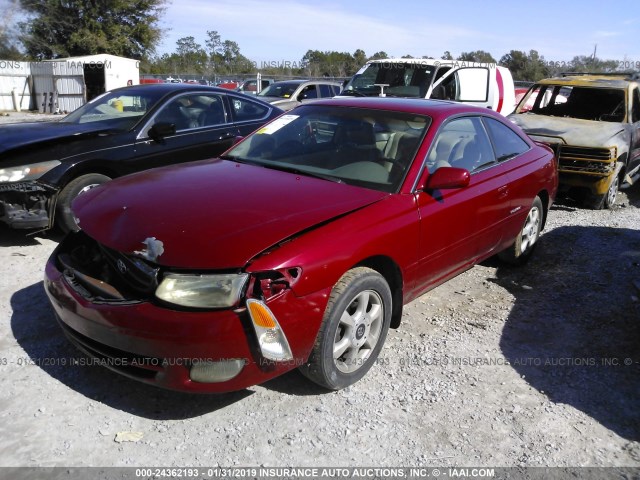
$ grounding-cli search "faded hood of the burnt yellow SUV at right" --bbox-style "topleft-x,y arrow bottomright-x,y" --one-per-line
509,113 -> 626,148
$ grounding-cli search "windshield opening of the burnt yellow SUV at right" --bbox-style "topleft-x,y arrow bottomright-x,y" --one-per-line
516,85 -> 626,122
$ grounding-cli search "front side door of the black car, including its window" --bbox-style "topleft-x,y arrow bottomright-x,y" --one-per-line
132,92 -> 238,170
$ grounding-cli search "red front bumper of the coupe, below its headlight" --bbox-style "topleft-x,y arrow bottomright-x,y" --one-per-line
44,236 -> 330,393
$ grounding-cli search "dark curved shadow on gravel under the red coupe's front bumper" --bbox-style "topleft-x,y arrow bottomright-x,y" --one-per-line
11,282 -> 254,420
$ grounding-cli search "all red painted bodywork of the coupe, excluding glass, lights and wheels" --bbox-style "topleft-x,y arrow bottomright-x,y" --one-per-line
45,97 -> 557,392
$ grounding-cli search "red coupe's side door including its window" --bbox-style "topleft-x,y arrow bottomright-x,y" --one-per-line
417,117 -> 509,288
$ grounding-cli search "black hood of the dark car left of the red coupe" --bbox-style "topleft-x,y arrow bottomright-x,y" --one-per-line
0,121 -> 119,160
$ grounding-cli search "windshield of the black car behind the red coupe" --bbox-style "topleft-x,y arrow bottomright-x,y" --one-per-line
62,88 -> 162,130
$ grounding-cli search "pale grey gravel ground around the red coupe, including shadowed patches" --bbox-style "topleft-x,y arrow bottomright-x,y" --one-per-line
0,113 -> 640,472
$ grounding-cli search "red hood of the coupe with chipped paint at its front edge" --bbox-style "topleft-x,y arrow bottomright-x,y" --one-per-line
73,160 -> 388,269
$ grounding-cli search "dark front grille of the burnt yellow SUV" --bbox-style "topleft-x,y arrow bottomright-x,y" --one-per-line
554,145 -> 617,177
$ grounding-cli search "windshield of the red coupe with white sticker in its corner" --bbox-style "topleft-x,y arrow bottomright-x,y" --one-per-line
222,105 -> 431,192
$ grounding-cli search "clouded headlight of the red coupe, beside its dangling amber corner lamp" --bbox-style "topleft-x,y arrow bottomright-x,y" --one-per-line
156,273 -> 249,308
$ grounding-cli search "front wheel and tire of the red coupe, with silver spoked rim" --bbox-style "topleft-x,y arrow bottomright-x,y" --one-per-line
300,267 -> 392,390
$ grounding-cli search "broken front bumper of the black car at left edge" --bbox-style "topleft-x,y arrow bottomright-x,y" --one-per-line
0,181 -> 56,229
